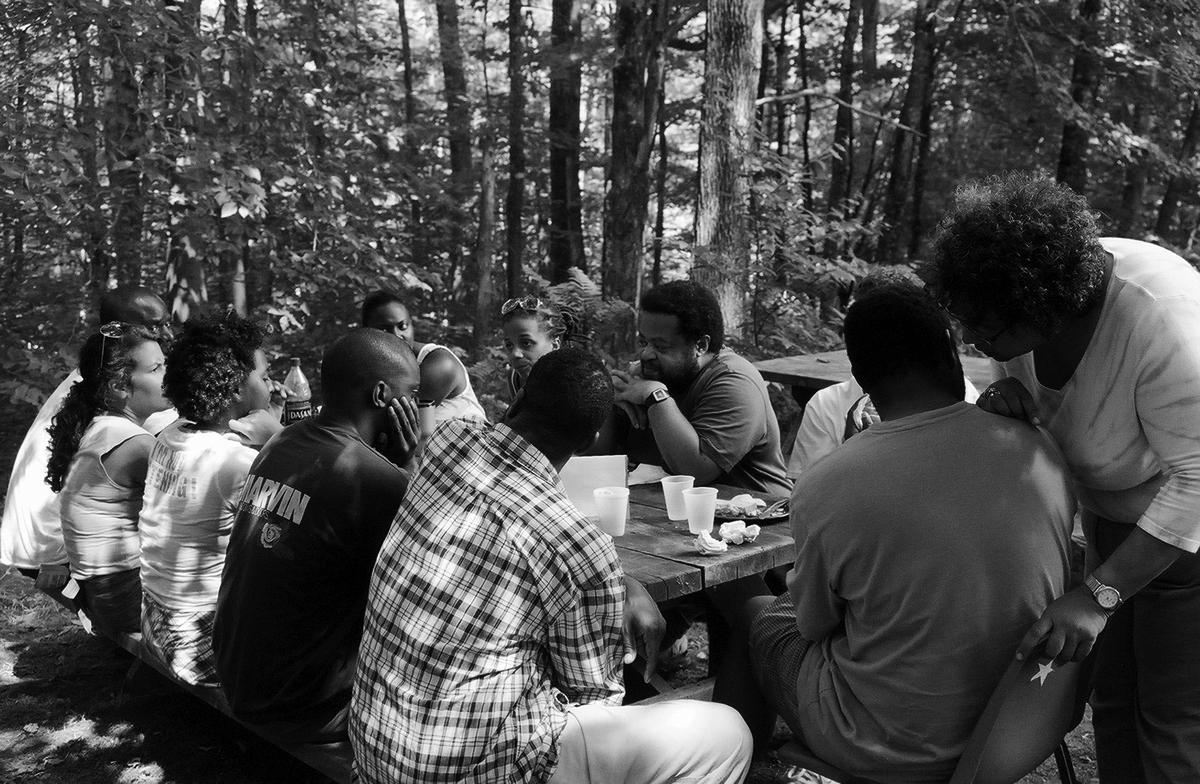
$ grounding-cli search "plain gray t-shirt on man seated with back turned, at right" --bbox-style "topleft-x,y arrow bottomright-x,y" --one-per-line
788,403 -> 1074,782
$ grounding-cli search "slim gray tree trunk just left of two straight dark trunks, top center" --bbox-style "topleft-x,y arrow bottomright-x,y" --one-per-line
437,0 -> 472,296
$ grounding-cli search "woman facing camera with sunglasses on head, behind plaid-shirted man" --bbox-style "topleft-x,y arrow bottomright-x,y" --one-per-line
500,295 -> 588,399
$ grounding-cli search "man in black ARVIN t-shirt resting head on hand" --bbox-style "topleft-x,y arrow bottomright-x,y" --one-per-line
212,328 -> 420,742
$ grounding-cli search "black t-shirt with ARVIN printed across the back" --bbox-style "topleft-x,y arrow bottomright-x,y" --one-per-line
214,418 -> 408,740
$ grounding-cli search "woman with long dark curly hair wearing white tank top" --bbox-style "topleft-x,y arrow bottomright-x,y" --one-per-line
46,322 -> 170,635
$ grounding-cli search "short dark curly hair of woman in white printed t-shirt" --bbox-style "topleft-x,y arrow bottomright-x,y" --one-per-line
162,311 -> 265,425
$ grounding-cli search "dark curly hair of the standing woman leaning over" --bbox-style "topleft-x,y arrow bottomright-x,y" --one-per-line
924,173 -> 1106,336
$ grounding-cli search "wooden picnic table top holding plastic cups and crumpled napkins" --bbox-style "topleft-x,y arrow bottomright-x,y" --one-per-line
616,484 -> 796,602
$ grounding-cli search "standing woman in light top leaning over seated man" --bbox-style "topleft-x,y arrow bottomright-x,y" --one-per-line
930,175 -> 1200,783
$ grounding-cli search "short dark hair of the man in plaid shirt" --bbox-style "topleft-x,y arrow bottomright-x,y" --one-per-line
522,346 -> 613,448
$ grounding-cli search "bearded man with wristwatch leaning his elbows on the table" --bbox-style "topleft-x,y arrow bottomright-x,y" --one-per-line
613,281 -> 791,496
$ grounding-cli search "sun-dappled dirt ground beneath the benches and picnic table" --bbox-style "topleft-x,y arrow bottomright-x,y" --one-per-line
0,571 -> 1096,784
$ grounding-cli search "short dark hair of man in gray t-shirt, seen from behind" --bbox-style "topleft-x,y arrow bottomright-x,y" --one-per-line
844,281 -> 966,399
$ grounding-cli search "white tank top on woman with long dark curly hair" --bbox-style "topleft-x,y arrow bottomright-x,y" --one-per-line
60,414 -> 150,580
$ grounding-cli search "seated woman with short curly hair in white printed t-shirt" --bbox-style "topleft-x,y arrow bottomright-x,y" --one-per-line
138,313 -> 281,684
